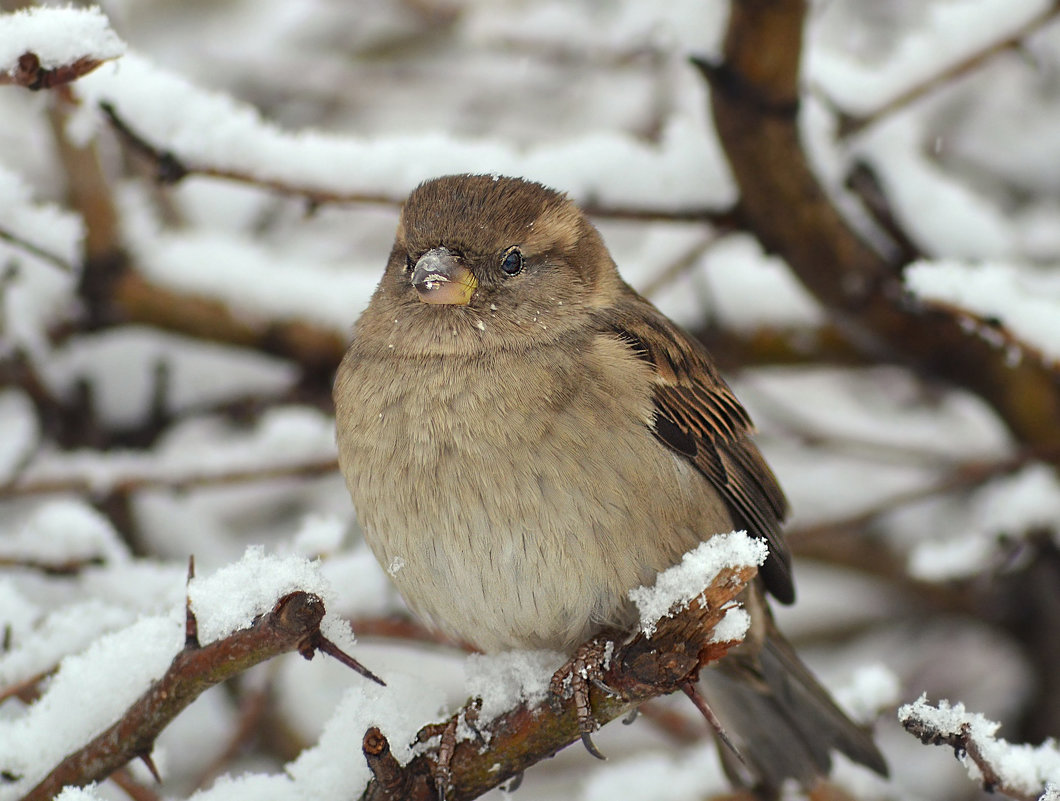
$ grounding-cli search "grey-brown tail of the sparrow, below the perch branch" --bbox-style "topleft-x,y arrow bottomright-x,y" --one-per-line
701,620 -> 887,798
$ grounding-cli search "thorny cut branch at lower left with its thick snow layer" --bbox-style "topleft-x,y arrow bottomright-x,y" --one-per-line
0,548 -> 383,801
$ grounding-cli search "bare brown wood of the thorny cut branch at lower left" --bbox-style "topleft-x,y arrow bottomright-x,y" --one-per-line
22,591 -> 377,801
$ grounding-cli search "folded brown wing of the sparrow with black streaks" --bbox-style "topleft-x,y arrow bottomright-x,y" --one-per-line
607,289 -> 795,603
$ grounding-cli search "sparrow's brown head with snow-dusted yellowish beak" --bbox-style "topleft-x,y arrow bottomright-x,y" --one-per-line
361,175 -> 621,353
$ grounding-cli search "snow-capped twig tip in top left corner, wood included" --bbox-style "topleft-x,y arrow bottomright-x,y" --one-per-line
0,6 -> 125,89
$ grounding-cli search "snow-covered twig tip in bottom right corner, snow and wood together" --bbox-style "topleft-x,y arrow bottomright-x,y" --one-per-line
898,695 -> 1060,801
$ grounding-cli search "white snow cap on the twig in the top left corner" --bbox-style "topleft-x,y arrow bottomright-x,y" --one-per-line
0,5 -> 125,73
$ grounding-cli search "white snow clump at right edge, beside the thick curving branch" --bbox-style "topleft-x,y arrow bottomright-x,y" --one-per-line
905,261 -> 1060,362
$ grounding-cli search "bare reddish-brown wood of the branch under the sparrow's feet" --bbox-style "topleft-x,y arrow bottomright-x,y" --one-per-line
363,568 -> 757,801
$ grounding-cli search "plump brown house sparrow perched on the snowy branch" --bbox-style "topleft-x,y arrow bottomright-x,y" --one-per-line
335,175 -> 886,793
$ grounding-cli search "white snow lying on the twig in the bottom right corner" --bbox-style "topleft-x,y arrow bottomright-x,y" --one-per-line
898,694 -> 1060,796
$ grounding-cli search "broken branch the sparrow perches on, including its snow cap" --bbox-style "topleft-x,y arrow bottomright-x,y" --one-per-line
363,532 -> 763,801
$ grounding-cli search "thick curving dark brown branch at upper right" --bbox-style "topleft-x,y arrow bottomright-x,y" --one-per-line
697,0 -> 1060,453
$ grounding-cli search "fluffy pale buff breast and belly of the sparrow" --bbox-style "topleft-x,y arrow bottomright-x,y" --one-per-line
336,334 -> 727,651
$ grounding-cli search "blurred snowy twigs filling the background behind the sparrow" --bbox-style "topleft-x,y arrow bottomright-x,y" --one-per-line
0,0 -> 1060,801
